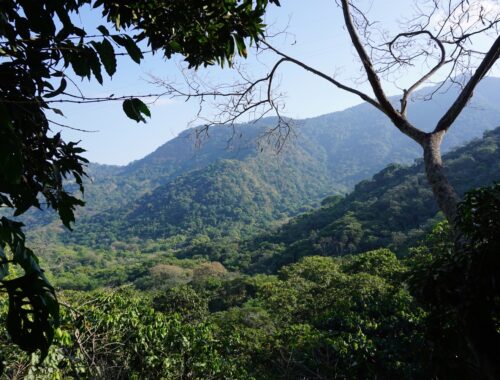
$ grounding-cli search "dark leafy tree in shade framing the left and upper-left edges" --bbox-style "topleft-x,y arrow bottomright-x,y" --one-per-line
0,0 -> 279,358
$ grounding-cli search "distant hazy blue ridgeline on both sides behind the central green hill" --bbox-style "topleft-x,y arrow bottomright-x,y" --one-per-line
69,78 -> 500,215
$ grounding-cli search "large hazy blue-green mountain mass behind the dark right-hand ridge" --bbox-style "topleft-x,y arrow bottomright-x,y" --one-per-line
23,78 -> 500,246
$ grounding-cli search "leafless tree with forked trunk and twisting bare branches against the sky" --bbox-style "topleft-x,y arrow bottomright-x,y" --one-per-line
153,0 -> 500,378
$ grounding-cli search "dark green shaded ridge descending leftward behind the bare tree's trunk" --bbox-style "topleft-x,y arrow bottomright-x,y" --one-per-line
240,127 -> 500,273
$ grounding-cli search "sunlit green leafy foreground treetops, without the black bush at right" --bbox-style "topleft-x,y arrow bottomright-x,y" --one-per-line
3,250 -> 438,379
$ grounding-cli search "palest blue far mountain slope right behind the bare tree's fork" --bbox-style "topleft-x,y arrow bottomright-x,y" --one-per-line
297,78 -> 500,187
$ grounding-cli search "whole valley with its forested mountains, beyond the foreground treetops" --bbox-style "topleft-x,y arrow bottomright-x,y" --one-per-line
21,78 -> 500,290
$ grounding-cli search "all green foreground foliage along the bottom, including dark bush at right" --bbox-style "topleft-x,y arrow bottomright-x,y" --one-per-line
1,184 -> 500,379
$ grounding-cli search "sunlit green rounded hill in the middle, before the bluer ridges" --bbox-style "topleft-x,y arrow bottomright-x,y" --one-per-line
64,142 -> 335,246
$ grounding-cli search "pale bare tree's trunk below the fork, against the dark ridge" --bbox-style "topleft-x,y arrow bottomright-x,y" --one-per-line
422,131 -> 459,226
